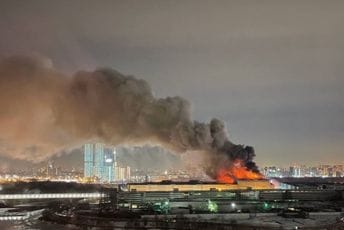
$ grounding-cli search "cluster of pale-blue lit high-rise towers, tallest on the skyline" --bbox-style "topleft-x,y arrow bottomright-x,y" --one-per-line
84,143 -> 116,182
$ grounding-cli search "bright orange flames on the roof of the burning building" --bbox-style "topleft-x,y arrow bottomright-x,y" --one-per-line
216,161 -> 263,184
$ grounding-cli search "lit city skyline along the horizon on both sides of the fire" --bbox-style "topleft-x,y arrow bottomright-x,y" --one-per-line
0,147 -> 344,180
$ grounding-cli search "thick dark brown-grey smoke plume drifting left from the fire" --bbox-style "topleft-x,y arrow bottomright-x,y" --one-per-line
0,56 -> 258,179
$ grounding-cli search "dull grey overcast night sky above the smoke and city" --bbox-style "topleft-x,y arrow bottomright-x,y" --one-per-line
0,0 -> 344,166
